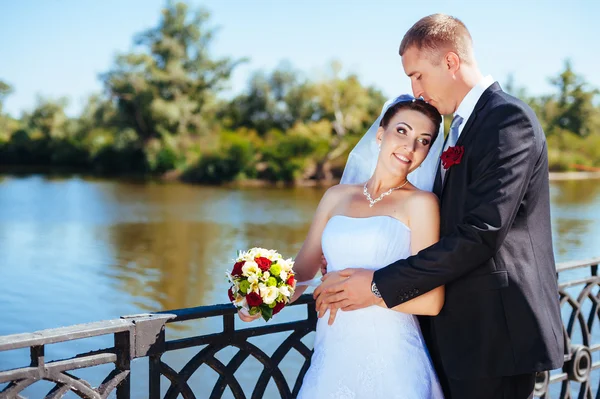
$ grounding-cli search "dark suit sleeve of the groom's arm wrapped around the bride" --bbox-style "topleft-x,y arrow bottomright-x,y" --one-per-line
374,104 -> 542,308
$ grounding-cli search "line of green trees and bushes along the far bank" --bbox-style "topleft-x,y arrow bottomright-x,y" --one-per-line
0,2 -> 600,184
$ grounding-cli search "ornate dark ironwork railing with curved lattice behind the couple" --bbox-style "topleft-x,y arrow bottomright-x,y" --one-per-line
0,258 -> 600,399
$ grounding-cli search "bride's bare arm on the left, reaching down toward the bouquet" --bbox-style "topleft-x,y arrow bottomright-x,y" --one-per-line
290,185 -> 344,302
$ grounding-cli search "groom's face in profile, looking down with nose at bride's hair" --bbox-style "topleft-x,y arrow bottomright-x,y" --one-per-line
402,47 -> 456,115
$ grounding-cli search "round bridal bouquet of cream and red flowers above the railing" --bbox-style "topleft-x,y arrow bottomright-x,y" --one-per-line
227,248 -> 296,321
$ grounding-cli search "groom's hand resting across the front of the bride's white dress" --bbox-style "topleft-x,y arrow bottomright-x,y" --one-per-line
314,269 -> 382,324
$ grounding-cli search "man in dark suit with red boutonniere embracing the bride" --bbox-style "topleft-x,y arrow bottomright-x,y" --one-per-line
315,14 -> 563,399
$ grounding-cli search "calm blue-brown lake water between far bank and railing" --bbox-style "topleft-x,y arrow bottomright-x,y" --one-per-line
0,175 -> 600,398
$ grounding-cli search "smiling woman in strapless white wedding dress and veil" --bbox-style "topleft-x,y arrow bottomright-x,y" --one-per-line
239,95 -> 444,399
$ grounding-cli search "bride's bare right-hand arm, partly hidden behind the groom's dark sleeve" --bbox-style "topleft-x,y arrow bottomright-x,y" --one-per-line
381,192 -> 445,316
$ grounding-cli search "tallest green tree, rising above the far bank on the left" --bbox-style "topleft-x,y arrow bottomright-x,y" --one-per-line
102,2 -> 240,143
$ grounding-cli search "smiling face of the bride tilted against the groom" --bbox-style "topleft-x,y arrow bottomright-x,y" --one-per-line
377,109 -> 435,176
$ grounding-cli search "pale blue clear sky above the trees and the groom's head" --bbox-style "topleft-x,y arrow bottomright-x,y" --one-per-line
0,0 -> 600,116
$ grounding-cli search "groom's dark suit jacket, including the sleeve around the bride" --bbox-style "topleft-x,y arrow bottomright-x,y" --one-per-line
374,83 -> 563,399
